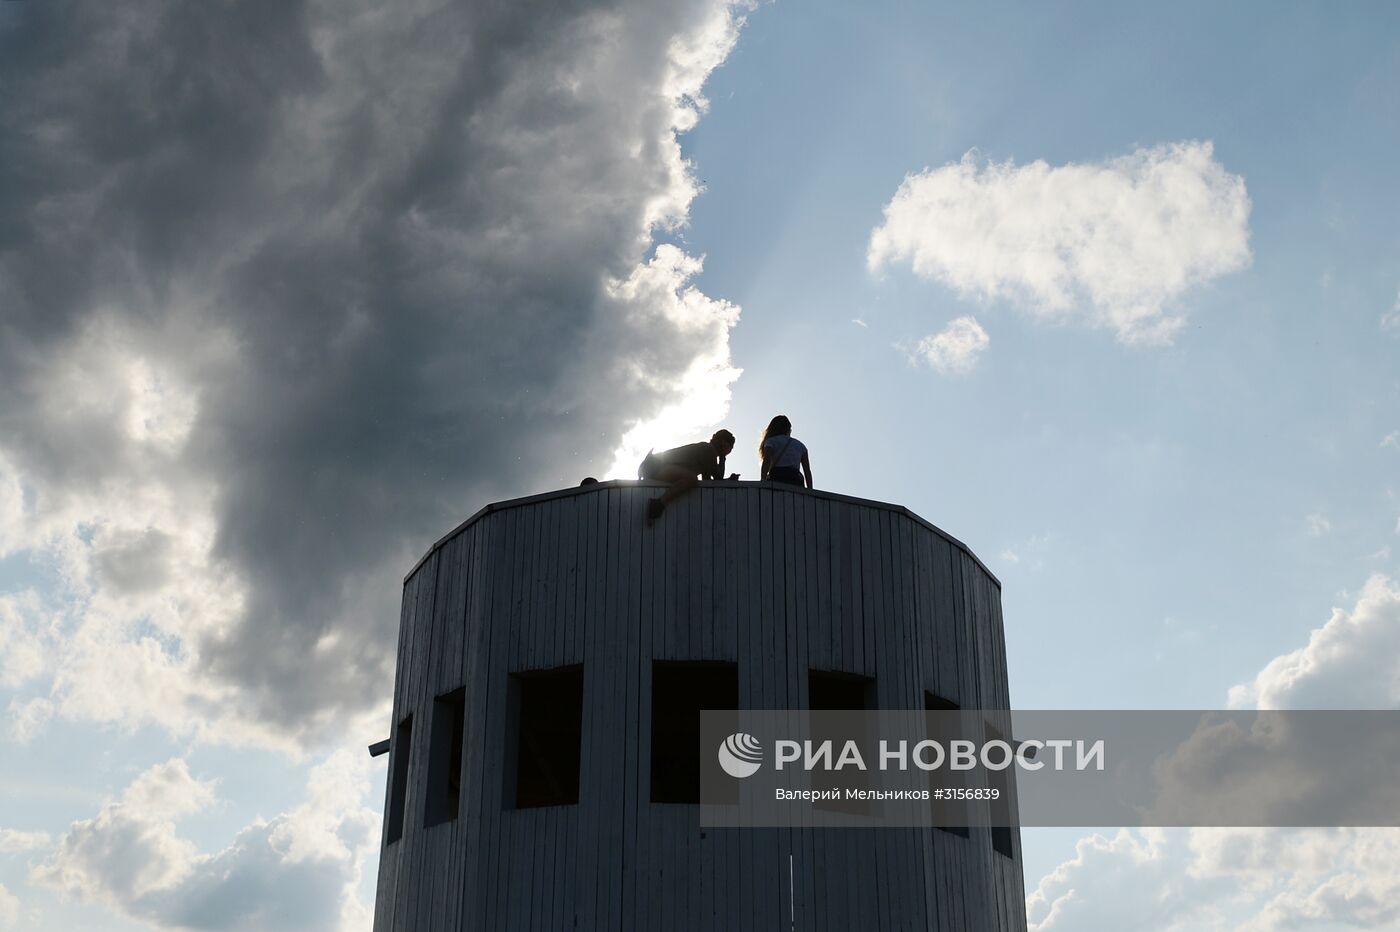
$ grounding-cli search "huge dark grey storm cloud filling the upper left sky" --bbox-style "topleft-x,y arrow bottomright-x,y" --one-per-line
0,0 -> 732,730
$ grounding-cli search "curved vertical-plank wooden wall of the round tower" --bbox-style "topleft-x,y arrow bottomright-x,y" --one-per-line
374,481 -> 1026,932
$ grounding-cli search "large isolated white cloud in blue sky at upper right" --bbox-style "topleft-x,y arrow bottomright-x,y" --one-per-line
867,141 -> 1250,343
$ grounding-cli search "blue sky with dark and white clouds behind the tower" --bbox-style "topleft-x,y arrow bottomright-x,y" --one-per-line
0,0 -> 1400,932
